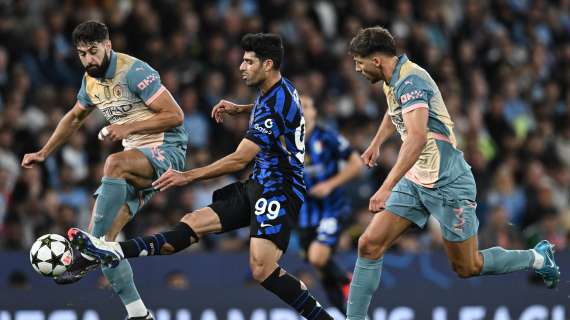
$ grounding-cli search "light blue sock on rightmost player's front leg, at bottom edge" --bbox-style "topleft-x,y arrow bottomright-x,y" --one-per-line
346,257 -> 383,320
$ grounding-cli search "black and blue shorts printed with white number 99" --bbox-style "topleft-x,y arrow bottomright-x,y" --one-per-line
209,180 -> 303,252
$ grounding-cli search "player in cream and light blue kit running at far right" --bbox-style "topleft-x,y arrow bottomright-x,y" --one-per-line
347,27 -> 560,320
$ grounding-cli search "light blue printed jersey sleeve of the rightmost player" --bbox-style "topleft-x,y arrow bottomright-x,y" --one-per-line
396,75 -> 432,113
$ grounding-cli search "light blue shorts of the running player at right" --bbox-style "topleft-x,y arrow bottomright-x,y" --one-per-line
386,171 -> 479,242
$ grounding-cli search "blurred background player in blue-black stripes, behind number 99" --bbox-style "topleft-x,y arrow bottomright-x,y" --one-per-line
297,95 -> 363,312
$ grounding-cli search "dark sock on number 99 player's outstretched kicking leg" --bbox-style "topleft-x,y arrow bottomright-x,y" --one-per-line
119,222 -> 199,258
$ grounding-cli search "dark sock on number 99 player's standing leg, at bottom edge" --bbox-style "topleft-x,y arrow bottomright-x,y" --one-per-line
261,267 -> 333,320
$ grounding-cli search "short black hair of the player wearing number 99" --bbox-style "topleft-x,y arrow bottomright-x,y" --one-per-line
241,33 -> 283,70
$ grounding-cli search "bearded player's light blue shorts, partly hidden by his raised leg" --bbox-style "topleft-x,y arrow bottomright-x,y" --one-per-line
94,145 -> 186,216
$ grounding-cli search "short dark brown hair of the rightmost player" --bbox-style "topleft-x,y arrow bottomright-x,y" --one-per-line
348,26 -> 396,57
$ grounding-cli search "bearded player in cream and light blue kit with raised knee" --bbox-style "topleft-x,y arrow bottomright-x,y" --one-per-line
22,21 -> 187,319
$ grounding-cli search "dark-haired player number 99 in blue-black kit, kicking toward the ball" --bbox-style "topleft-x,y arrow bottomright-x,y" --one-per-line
68,34 -> 332,320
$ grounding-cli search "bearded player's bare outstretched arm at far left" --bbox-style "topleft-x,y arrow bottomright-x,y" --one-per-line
22,102 -> 93,168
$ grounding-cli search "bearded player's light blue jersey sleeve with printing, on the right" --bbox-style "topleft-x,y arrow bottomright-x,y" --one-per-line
127,60 -> 166,105
